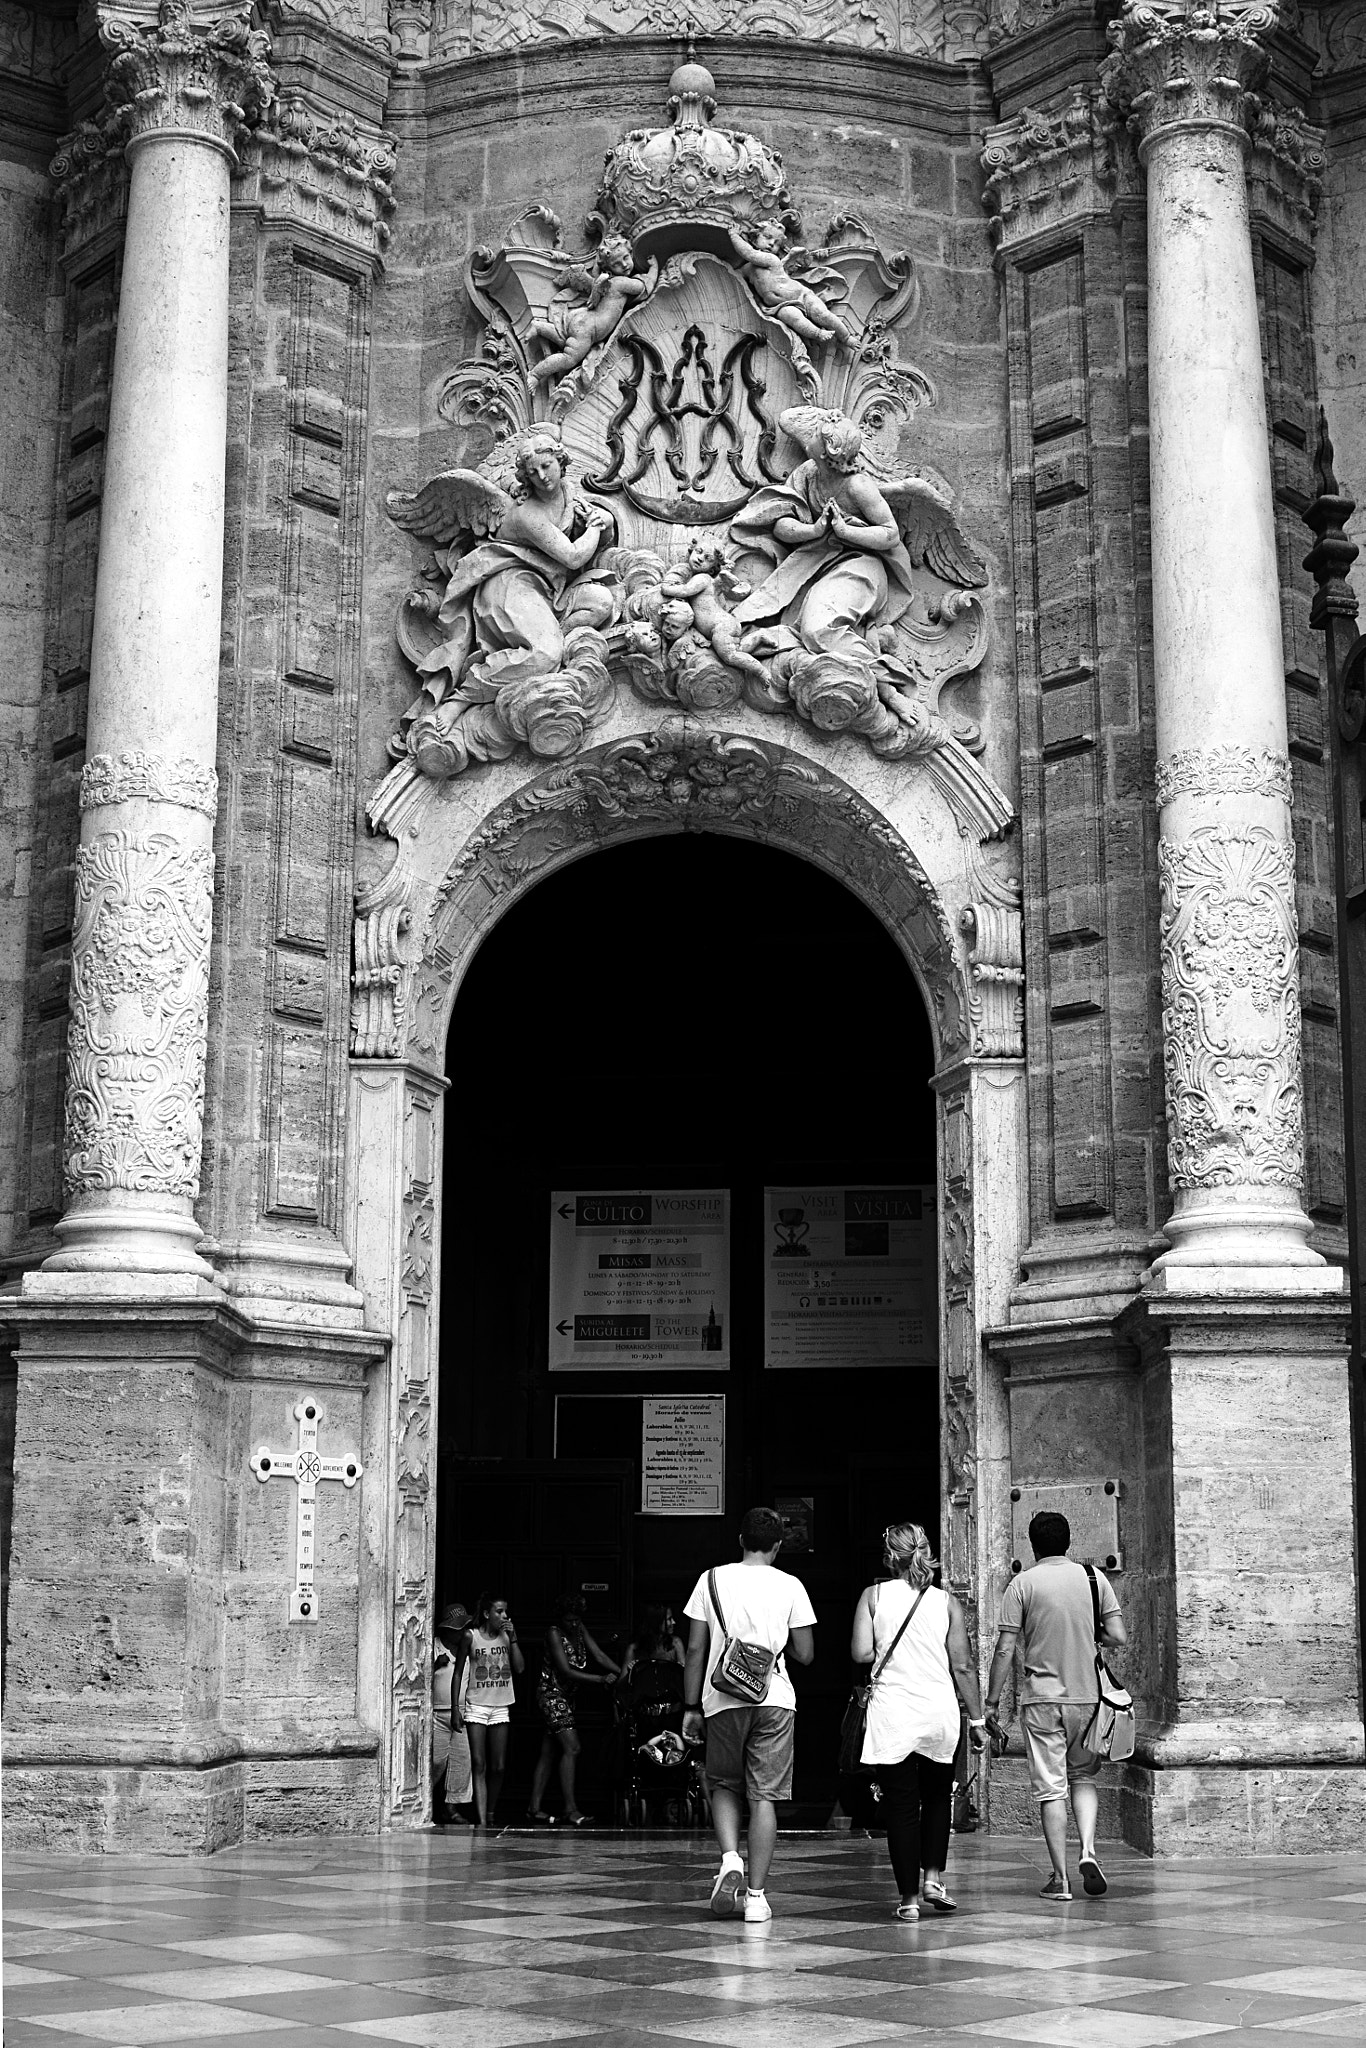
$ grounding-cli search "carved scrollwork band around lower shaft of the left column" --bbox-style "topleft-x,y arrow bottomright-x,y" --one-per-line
66,831 -> 213,1200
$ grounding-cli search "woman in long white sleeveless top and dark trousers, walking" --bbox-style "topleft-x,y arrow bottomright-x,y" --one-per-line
850,1522 -> 987,1921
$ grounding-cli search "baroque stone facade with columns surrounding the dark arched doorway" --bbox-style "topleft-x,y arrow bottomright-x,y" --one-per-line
0,0 -> 1366,1853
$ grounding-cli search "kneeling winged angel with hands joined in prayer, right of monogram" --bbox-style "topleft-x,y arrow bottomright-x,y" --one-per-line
731,406 -> 987,754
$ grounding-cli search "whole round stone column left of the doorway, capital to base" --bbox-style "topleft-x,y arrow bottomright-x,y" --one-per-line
31,0 -> 270,1292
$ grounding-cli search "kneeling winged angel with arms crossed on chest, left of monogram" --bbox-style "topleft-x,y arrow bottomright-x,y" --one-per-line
387,426 -> 618,776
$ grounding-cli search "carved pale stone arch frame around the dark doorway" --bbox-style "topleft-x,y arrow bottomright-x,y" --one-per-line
348,717 -> 1024,1825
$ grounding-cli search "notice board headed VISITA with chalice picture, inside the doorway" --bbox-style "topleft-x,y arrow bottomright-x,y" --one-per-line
764,1186 -> 940,1368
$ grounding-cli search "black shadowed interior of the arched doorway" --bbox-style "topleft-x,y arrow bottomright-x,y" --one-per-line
436,834 -> 938,1821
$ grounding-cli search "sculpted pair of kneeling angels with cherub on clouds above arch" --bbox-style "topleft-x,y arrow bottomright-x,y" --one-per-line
387,406 -> 987,778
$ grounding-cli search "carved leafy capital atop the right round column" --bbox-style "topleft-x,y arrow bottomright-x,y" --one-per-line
1100,0 -> 1282,160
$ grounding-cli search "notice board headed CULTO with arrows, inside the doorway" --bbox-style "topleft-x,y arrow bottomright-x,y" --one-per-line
551,1188 -> 731,1372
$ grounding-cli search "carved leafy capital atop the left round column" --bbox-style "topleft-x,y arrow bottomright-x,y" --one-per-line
98,0 -> 274,156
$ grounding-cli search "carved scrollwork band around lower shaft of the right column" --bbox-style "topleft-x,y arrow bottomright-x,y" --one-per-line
1157,825 -> 1305,1188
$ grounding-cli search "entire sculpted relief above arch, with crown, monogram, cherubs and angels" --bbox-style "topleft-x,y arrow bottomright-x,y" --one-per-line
371,63 -> 1012,840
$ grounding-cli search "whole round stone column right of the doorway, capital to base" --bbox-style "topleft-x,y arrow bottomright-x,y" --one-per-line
1106,0 -> 1339,1290
